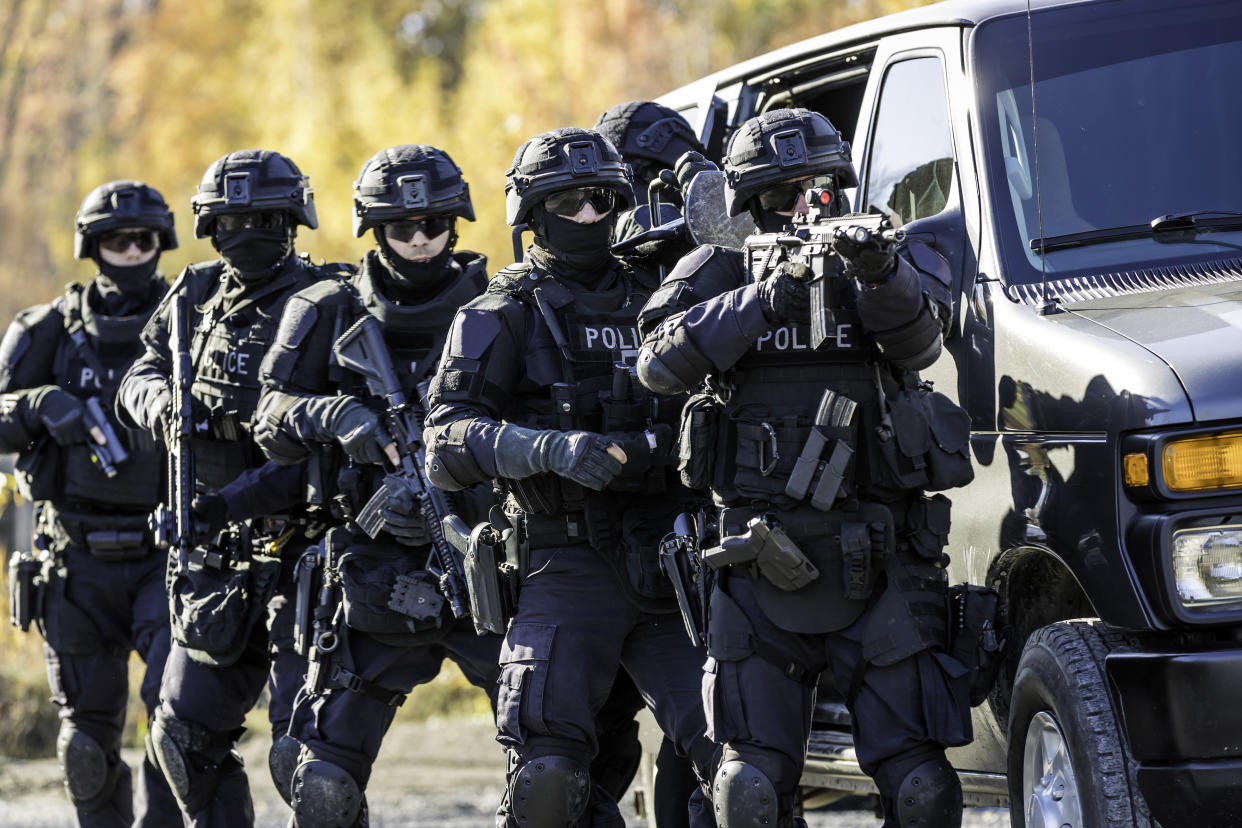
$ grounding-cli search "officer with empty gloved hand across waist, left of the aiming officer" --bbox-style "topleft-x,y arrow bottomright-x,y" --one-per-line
425,128 -> 715,828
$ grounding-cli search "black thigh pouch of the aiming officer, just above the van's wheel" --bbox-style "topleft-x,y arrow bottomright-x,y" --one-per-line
949,583 -> 1009,708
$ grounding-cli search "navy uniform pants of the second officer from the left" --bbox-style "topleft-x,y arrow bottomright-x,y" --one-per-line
160,541 -> 306,828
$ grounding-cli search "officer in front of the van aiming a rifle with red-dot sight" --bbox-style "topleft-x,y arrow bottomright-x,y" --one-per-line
638,109 -> 970,828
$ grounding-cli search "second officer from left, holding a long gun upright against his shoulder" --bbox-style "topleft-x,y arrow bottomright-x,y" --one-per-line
119,150 -> 340,826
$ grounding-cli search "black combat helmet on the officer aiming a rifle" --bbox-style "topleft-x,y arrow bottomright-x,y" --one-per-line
724,109 -> 858,216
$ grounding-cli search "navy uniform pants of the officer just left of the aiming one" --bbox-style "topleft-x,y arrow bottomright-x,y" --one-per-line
496,544 -> 717,827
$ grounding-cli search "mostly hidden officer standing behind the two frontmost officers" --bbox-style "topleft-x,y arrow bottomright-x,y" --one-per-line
591,101 -> 715,828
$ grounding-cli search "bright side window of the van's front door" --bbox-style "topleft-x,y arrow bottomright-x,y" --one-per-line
866,57 -> 953,227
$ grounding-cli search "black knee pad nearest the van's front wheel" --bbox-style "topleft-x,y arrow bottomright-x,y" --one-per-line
876,750 -> 961,828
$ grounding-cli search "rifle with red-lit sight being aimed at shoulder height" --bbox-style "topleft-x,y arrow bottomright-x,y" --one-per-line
743,187 -> 905,349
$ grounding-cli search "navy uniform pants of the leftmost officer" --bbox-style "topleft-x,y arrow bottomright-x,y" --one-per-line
43,545 -> 180,828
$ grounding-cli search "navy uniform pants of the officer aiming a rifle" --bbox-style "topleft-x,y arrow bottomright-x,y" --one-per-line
703,570 -> 971,824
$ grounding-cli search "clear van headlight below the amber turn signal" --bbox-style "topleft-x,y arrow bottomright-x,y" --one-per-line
1172,525 -> 1242,607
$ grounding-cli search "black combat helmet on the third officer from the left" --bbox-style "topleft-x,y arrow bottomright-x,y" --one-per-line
354,144 -> 474,237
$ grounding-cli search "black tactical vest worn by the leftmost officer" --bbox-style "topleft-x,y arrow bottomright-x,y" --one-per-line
52,284 -> 166,511
